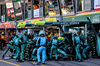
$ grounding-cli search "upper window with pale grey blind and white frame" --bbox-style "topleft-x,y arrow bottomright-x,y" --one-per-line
76,0 -> 91,12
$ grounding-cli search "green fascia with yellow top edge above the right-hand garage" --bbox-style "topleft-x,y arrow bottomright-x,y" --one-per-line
63,11 -> 100,23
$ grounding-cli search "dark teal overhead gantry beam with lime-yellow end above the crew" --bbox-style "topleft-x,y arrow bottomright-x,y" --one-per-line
24,21 -> 89,27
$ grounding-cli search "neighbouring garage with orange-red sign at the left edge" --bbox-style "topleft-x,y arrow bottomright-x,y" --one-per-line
0,22 -> 16,45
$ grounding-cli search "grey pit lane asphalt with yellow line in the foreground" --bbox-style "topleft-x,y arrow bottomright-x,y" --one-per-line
0,50 -> 100,66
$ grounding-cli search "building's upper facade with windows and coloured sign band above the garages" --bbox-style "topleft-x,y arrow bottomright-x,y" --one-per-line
0,0 -> 100,28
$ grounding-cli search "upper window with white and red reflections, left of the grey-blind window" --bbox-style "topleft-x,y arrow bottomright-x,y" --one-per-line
61,0 -> 74,15
